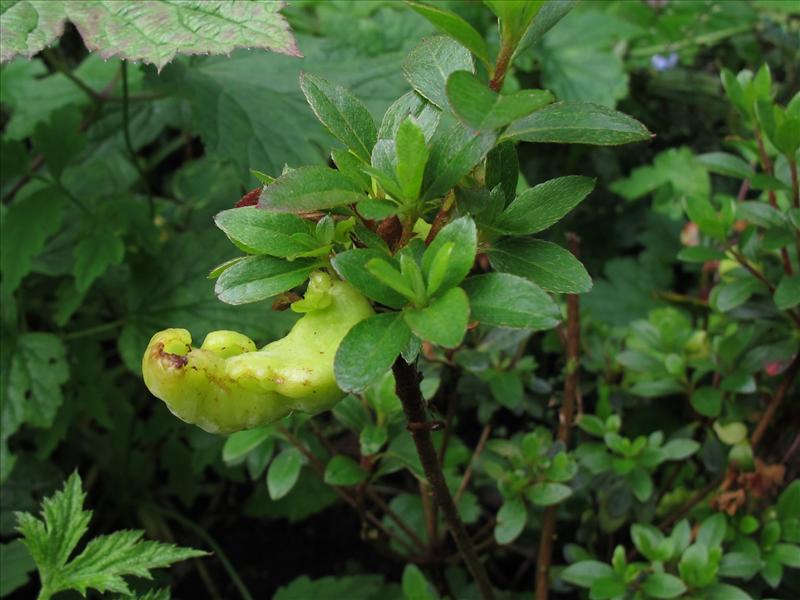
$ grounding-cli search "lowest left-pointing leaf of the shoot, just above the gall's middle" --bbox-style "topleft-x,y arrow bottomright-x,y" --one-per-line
214,256 -> 317,304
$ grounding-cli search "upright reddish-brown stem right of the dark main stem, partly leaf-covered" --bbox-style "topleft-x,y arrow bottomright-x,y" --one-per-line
536,233 -> 581,600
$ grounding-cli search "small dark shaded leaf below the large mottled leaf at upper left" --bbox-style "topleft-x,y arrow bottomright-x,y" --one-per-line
32,104 -> 86,181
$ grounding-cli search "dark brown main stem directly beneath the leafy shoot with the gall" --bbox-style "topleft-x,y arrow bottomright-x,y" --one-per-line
392,357 -> 494,600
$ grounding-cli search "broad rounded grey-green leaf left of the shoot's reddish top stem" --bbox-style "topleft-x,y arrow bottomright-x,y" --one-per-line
403,36 -> 475,109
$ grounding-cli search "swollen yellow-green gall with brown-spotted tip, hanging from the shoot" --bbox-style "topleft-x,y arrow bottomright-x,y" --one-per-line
142,272 -> 373,433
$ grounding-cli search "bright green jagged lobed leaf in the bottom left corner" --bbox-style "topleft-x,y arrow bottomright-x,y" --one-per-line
16,473 -> 205,598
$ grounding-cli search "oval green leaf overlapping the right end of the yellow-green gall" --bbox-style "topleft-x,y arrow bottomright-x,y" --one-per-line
334,313 -> 411,392
